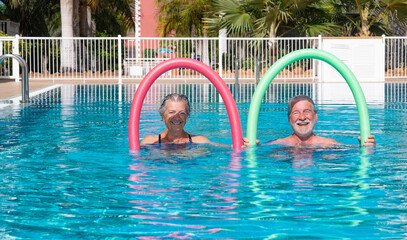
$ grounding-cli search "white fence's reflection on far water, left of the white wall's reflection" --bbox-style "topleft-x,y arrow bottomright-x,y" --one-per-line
31,83 -> 315,105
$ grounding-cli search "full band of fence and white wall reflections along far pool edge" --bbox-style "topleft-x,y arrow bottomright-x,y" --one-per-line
23,81 -> 407,105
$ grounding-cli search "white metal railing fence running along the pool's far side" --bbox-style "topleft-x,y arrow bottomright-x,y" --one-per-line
0,36 -> 407,83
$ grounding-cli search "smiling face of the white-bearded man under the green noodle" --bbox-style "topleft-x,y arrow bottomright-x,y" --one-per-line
288,100 -> 318,140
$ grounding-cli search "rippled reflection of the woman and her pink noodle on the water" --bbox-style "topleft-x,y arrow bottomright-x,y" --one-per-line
127,144 -> 242,239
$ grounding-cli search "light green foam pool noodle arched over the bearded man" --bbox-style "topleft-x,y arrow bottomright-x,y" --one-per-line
246,49 -> 370,146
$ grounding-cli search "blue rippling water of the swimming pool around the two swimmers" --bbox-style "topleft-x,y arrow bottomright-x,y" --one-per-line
0,84 -> 407,239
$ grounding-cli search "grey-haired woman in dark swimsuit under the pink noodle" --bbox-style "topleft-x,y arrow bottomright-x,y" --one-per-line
141,93 -> 210,144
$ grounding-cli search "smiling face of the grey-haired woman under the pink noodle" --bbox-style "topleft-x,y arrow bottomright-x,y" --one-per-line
162,100 -> 188,131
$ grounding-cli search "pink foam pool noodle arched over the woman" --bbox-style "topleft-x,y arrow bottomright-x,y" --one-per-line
129,58 -> 242,150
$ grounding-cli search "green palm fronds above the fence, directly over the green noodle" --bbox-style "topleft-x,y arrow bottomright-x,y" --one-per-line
207,0 -> 339,38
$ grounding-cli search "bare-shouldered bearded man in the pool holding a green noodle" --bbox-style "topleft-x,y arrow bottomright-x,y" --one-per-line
244,95 -> 376,146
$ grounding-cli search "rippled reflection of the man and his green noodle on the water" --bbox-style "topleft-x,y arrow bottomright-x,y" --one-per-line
242,143 -> 380,227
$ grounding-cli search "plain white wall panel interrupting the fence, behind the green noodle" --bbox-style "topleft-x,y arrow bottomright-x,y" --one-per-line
318,38 -> 385,103
